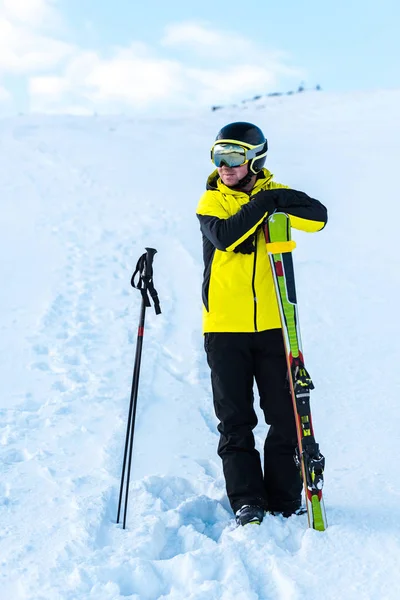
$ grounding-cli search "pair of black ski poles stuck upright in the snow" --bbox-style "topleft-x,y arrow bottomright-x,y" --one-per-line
117,248 -> 161,529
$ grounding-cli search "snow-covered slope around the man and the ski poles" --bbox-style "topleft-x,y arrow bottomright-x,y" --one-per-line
0,90 -> 400,600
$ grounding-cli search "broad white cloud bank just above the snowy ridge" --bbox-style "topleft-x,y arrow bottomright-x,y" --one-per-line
29,23 -> 303,112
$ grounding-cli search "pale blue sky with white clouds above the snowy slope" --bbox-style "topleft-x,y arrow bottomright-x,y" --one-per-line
0,0 -> 400,114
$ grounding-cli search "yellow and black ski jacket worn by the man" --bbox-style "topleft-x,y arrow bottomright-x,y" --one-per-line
196,169 -> 327,333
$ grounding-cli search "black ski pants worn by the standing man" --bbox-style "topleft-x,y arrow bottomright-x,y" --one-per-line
204,329 -> 302,512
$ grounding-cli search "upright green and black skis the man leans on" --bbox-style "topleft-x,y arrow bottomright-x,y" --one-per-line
264,212 -> 327,531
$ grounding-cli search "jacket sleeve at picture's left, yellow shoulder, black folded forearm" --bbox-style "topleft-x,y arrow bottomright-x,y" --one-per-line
197,191 -> 272,252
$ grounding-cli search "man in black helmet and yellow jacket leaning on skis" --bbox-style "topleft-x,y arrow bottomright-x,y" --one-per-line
197,122 -> 327,525
